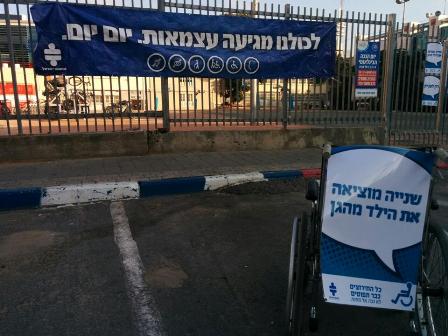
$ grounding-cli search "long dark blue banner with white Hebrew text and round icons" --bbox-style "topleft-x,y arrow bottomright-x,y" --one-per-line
31,3 -> 336,78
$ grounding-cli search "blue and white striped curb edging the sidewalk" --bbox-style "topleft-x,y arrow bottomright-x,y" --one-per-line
0,170 -> 303,210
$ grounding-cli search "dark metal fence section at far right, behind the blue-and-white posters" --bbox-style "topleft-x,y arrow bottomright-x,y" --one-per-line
387,19 -> 447,146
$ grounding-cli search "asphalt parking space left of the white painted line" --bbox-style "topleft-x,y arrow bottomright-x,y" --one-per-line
0,204 -> 135,336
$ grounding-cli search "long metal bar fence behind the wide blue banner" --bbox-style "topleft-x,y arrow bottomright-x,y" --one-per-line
0,0 -> 445,147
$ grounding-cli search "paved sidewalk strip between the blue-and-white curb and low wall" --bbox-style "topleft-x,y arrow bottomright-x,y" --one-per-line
0,148 -> 321,188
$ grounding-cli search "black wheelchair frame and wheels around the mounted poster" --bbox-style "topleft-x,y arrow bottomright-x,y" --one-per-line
285,145 -> 448,336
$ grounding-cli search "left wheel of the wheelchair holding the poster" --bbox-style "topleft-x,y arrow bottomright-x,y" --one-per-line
286,214 -> 308,336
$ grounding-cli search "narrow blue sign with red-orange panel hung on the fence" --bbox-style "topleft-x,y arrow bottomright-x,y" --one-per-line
355,41 -> 380,98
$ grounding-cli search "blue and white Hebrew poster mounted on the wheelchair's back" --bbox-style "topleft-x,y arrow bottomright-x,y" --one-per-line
321,146 -> 433,310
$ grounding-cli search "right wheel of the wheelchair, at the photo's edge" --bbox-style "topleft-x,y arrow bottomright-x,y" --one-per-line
417,223 -> 448,336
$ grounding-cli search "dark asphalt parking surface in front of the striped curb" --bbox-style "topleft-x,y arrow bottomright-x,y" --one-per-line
0,177 -> 448,336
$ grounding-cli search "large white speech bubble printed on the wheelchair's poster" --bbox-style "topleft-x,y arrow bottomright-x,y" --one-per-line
322,149 -> 431,272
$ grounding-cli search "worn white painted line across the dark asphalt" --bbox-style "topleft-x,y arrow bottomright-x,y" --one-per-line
110,202 -> 163,336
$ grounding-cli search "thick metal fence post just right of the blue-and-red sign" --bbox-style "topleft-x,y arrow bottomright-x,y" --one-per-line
381,14 -> 397,144
